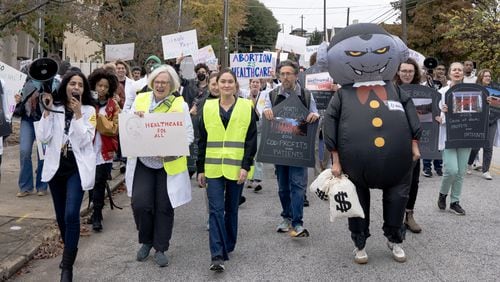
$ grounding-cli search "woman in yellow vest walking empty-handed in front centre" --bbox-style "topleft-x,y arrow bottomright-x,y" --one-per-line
198,69 -> 257,272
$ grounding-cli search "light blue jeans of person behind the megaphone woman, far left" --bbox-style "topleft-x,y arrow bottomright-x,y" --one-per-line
18,118 -> 47,192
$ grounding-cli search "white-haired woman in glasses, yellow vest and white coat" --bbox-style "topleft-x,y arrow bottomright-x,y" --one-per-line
125,65 -> 194,267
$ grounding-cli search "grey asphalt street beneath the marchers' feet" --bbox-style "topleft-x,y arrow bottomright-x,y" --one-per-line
9,152 -> 500,281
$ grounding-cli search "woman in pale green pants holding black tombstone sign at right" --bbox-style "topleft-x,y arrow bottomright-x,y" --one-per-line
436,62 -> 471,215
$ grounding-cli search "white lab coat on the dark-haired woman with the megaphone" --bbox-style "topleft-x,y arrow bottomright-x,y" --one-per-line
37,105 -> 96,190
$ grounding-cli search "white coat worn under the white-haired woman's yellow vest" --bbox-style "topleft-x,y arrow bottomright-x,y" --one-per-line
125,98 -> 194,208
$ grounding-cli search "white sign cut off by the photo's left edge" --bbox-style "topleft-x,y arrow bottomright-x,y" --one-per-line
0,62 -> 26,119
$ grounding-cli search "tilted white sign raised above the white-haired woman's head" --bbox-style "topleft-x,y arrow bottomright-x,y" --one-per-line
161,29 -> 198,60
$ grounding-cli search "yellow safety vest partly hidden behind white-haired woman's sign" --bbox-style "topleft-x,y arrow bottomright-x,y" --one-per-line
135,92 -> 187,175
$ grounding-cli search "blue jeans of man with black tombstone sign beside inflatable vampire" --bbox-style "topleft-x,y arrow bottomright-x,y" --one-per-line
276,165 -> 307,228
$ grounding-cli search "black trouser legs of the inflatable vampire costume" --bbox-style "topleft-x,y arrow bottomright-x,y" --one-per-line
348,166 -> 412,249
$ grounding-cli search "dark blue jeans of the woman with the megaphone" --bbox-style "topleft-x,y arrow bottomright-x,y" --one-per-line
49,172 -> 84,249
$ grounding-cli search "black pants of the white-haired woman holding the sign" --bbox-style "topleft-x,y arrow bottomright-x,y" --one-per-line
132,160 -> 174,252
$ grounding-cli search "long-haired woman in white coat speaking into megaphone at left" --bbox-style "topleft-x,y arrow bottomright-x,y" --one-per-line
37,72 -> 96,281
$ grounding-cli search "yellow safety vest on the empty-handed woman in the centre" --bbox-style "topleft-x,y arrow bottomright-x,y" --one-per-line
203,98 -> 253,180
